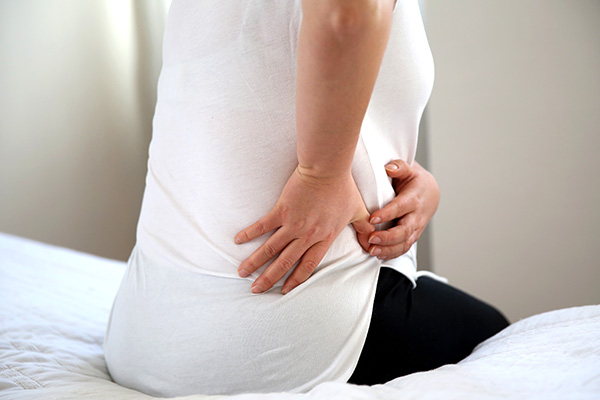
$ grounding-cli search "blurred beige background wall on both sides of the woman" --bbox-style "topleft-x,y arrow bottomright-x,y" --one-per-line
0,0 -> 600,320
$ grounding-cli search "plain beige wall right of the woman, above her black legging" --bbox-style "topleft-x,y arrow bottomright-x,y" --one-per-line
425,0 -> 600,320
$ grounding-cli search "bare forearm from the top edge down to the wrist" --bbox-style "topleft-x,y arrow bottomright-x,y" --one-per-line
296,0 -> 394,177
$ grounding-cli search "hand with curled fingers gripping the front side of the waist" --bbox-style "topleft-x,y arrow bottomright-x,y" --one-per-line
358,160 -> 440,260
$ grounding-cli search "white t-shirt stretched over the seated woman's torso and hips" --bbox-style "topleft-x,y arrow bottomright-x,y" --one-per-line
105,0 -> 433,396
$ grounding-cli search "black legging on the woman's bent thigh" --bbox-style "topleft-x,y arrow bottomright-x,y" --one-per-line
349,267 -> 509,385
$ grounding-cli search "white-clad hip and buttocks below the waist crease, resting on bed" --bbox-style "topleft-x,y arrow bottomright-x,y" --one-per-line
105,245 -> 379,396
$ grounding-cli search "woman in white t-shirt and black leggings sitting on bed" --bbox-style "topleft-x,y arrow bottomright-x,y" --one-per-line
105,0 -> 506,396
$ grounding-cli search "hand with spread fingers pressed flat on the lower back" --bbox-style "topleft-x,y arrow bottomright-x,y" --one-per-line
235,166 -> 374,294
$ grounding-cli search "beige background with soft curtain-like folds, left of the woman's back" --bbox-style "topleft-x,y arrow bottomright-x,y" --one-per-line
0,0 -> 166,259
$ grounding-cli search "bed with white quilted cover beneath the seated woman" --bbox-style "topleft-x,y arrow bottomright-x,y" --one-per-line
0,233 -> 600,400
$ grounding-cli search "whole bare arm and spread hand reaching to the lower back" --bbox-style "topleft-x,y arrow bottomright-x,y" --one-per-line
234,0 -> 404,294
